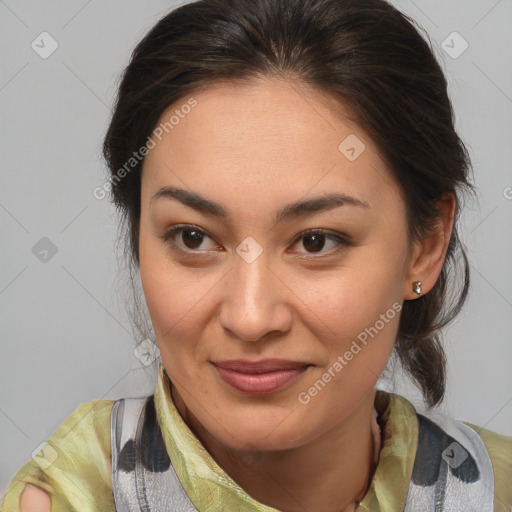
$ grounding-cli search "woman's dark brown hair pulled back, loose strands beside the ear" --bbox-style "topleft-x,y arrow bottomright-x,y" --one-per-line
103,0 -> 473,407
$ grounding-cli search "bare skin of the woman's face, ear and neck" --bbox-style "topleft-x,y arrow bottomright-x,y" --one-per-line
20,78 -> 455,512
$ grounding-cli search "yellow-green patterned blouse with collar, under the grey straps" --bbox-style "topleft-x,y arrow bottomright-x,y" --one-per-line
1,365 -> 512,512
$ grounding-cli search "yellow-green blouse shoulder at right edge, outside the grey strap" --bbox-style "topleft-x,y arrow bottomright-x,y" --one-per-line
463,421 -> 512,512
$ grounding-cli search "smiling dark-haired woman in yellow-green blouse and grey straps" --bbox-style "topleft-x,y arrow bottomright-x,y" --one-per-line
3,0 -> 512,512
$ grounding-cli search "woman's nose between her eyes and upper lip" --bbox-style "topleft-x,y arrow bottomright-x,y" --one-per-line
219,242 -> 293,341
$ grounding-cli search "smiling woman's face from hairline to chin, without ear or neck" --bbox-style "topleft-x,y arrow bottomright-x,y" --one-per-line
139,79 -> 414,450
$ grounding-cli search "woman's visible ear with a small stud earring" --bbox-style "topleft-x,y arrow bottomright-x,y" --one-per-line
403,193 -> 457,300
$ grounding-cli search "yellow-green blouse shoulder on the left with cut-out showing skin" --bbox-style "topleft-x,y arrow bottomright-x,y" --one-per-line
0,400 -> 115,512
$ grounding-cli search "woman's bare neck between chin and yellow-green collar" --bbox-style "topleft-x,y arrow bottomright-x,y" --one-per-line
171,380 -> 380,512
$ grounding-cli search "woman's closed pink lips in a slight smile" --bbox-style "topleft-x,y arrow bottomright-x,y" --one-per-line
213,359 -> 310,395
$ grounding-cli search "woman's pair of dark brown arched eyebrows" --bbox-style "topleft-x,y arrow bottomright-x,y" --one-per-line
150,187 -> 371,224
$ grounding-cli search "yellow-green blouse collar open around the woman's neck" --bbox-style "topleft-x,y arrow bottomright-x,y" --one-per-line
155,363 -> 418,512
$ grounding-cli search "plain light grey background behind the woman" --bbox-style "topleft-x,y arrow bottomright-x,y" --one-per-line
0,0 -> 512,497
